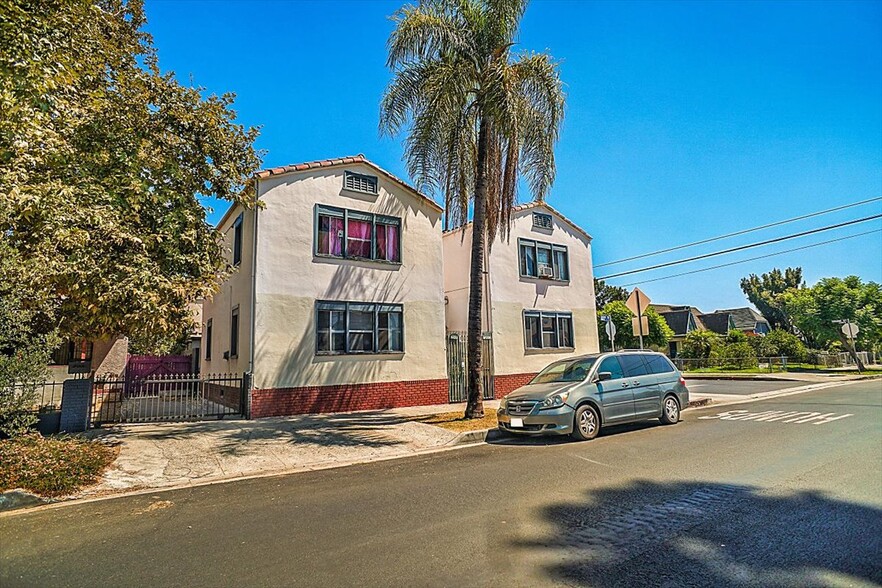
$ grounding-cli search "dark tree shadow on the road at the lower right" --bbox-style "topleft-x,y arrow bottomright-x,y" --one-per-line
512,481 -> 882,587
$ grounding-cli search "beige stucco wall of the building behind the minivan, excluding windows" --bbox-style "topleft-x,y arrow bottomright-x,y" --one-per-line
444,207 -> 599,374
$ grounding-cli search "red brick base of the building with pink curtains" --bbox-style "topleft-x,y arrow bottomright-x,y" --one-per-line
251,378 -> 448,418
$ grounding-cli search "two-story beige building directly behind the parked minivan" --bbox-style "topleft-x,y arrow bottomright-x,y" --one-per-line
444,203 -> 599,397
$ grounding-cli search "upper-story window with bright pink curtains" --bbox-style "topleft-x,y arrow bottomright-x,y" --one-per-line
315,206 -> 401,263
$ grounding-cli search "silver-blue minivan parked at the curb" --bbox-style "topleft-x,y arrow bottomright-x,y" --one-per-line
496,350 -> 689,440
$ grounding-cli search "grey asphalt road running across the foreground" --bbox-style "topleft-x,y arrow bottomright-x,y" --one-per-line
0,380 -> 882,588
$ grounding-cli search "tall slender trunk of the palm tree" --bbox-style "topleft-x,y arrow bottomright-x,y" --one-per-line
465,119 -> 490,419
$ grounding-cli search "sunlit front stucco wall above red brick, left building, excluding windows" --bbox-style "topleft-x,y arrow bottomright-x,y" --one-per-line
254,164 -> 446,388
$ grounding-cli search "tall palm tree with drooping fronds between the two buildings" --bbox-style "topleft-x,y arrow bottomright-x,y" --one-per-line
380,0 -> 564,418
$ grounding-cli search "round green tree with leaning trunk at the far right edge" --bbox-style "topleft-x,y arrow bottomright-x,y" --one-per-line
783,276 -> 882,369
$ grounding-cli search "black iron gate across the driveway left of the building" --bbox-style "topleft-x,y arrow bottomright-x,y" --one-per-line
89,374 -> 251,427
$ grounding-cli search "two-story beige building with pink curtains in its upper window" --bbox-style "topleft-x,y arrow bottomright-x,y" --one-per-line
202,155 -> 448,417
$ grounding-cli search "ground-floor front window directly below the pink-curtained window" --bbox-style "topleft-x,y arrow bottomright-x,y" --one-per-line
315,301 -> 404,355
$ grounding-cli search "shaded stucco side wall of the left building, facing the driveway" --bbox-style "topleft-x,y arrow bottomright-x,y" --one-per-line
201,206 -> 255,374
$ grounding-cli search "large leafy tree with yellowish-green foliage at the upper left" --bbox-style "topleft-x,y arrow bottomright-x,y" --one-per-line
0,0 -> 260,351
